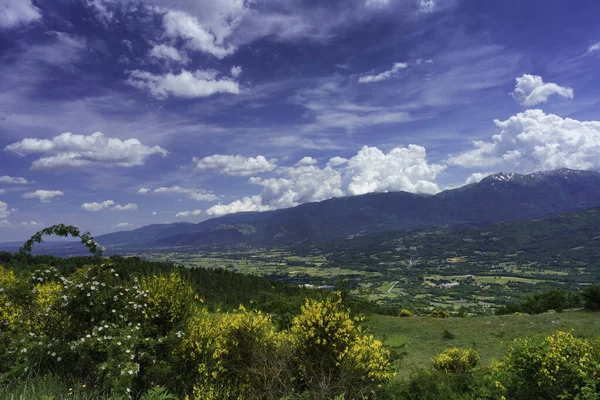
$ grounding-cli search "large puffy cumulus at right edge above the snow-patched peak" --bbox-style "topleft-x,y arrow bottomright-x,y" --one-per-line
448,110 -> 600,173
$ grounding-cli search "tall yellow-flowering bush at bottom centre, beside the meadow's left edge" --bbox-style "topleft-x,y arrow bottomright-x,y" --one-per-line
291,294 -> 392,398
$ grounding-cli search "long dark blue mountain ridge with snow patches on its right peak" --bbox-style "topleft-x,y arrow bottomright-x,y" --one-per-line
97,169 -> 600,250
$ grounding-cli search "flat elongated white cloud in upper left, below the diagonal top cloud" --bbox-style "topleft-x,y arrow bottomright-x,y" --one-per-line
127,69 -> 240,99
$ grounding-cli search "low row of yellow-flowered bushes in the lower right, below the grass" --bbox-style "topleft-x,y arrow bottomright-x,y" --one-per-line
388,331 -> 600,400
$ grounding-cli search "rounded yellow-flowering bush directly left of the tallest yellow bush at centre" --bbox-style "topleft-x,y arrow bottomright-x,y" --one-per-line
176,306 -> 291,399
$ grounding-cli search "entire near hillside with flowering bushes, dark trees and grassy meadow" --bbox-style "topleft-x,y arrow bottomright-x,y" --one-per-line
0,225 -> 600,400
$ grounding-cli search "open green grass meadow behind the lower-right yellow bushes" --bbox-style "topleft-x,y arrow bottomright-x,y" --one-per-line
366,311 -> 600,377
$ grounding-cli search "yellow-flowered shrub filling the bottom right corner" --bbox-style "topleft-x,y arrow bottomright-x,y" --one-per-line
499,331 -> 600,400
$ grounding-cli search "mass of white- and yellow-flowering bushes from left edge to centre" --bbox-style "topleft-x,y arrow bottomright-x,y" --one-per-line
0,258 -> 391,399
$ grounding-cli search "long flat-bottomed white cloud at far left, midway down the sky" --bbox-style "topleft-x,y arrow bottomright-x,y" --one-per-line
4,132 -> 167,169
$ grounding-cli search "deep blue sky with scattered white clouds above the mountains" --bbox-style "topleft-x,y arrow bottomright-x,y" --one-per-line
0,0 -> 600,242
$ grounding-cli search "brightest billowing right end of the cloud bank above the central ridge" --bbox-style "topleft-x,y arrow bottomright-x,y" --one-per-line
344,144 -> 446,195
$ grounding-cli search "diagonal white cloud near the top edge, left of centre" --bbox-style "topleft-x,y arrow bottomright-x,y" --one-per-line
163,10 -> 236,59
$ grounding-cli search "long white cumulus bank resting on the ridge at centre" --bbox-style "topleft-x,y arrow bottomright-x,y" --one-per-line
207,145 -> 446,215
